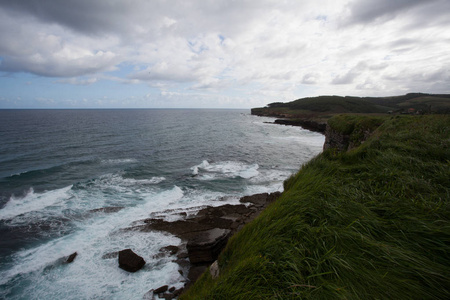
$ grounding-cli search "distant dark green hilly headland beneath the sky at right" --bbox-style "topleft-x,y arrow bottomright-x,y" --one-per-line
252,93 -> 450,119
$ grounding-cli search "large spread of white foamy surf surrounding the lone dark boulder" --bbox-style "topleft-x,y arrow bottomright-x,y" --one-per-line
0,186 -> 190,299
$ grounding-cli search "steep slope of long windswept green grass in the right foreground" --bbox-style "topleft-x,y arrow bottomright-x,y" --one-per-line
182,116 -> 450,299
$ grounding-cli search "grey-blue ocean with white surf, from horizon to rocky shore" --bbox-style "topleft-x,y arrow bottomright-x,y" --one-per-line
0,109 -> 324,299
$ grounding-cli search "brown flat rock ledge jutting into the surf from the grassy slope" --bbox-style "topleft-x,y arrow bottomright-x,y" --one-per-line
130,192 -> 281,285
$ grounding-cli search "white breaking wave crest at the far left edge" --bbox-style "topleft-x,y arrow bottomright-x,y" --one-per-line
0,185 -> 72,220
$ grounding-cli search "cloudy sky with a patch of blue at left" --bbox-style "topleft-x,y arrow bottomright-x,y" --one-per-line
0,0 -> 450,108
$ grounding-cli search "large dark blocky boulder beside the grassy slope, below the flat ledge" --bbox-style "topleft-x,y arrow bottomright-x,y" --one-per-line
186,228 -> 231,264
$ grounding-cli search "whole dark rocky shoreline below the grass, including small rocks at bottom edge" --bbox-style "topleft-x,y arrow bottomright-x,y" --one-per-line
126,192 -> 281,299
